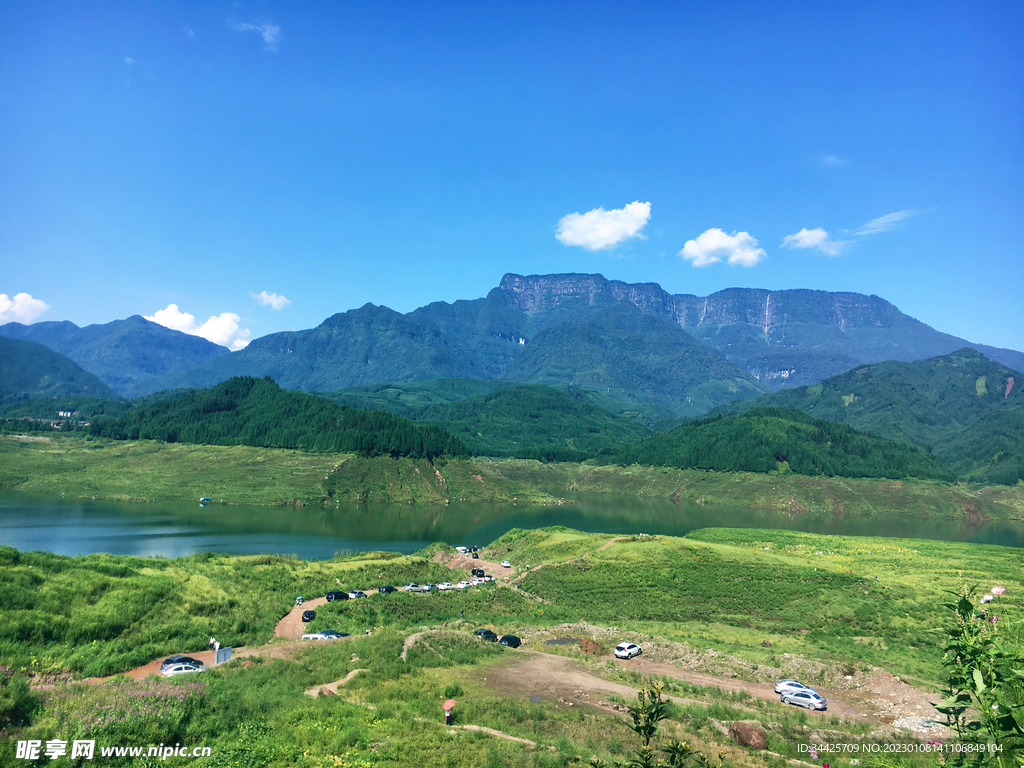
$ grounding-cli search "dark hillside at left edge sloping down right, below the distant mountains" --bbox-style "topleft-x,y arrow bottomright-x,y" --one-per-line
0,336 -> 117,405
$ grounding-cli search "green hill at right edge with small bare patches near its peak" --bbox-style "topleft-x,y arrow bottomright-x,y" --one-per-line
715,348 -> 1024,483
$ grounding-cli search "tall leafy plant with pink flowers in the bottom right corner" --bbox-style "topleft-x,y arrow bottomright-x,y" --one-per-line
936,585 -> 1024,768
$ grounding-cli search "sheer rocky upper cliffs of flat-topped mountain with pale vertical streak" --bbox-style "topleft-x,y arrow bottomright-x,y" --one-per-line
499,273 -> 1024,388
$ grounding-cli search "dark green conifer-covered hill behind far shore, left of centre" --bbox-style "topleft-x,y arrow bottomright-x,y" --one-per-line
90,376 -> 469,459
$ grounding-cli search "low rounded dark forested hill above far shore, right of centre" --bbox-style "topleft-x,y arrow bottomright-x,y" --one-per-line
597,408 -> 955,481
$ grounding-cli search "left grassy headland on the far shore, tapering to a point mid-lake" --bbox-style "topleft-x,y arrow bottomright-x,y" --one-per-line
0,436 -> 550,507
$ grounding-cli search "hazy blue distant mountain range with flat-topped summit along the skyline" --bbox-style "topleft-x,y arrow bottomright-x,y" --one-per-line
0,273 -> 1024,423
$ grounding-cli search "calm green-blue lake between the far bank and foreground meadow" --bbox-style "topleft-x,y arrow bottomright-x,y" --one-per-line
0,492 -> 1024,559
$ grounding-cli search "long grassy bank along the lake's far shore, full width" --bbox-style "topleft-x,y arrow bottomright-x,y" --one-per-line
0,436 -> 1024,520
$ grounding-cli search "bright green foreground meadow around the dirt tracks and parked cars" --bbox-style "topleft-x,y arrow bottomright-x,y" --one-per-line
0,527 -> 1024,768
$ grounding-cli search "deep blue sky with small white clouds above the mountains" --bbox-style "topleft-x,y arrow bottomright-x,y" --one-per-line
0,0 -> 1024,349
